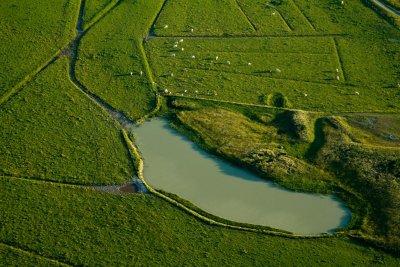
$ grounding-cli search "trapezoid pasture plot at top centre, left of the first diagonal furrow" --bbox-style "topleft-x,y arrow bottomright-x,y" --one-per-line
153,0 -> 254,36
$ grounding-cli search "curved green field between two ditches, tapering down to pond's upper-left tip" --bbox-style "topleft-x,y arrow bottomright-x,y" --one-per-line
76,0 -> 162,120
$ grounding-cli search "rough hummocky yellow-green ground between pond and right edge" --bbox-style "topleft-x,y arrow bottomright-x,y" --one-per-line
170,99 -> 400,254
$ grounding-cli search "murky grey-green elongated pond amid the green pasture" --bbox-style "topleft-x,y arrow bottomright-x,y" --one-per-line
135,118 -> 351,235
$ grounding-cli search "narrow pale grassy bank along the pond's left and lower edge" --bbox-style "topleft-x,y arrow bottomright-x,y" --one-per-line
120,132 -> 340,239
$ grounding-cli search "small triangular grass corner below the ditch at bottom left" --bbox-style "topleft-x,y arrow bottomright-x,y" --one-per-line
0,243 -> 66,266
